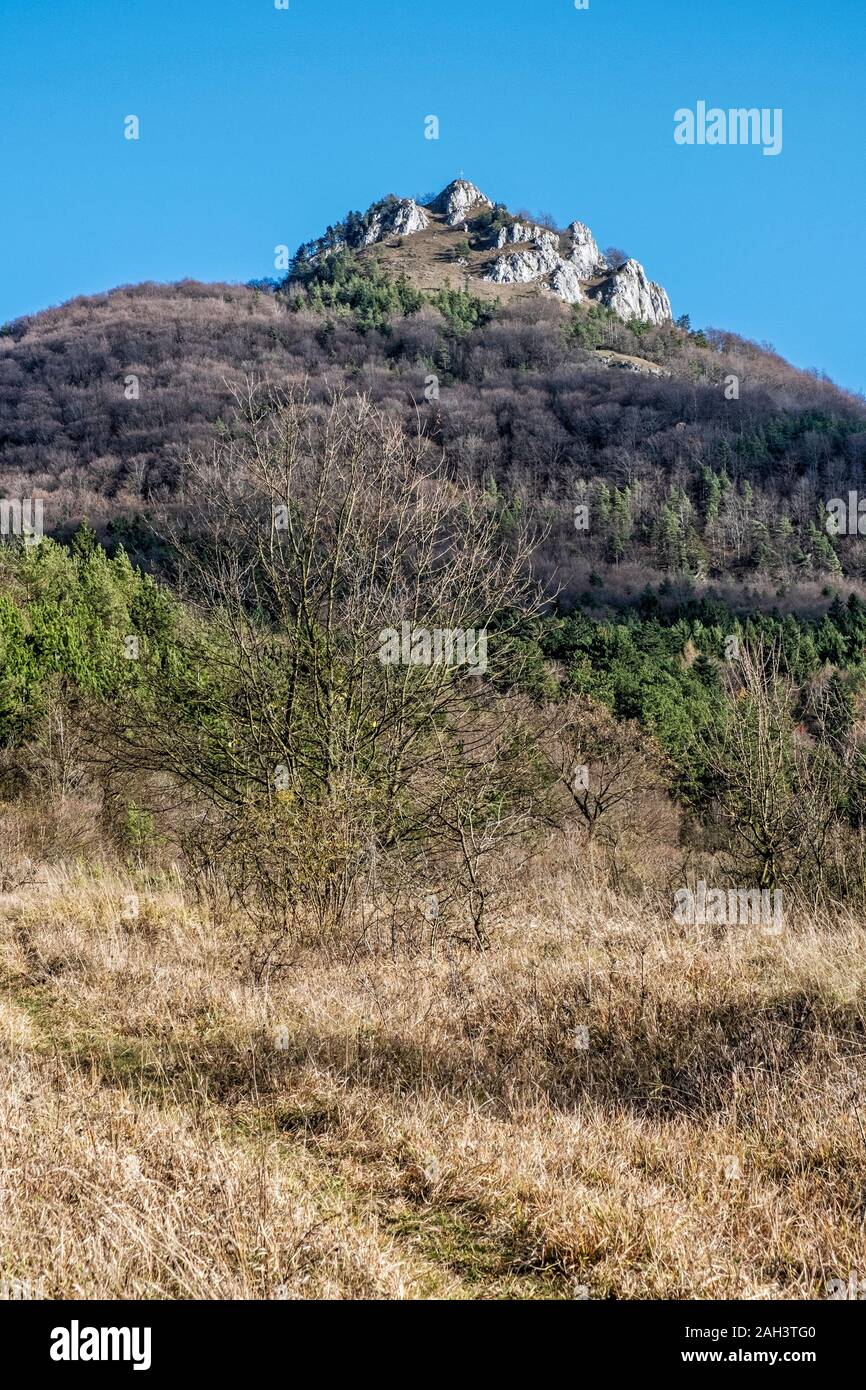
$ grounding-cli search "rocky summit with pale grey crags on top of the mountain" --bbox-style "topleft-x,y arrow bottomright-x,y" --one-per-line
300,178 -> 671,324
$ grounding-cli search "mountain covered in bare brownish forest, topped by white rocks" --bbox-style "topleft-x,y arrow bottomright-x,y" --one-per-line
0,177 -> 866,607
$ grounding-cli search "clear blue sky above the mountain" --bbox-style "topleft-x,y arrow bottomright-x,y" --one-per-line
0,0 -> 866,391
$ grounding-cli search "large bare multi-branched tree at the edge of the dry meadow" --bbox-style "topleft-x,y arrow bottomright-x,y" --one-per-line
108,386 -> 538,956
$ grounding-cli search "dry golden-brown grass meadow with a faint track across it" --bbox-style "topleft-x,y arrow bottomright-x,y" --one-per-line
0,870 -> 866,1298
